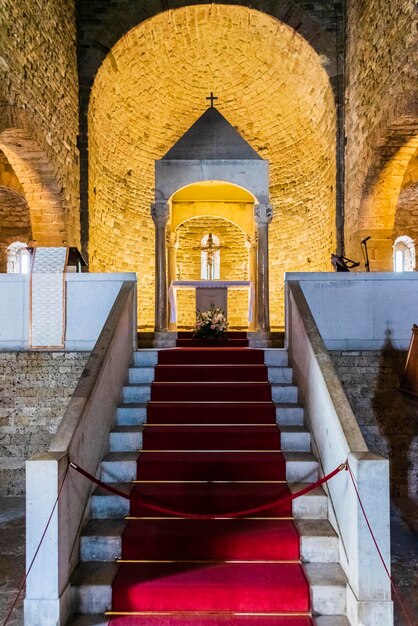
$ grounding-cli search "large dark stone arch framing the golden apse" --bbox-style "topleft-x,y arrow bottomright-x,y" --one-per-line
78,0 -> 344,256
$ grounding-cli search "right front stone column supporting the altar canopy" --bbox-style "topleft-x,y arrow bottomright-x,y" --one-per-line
254,204 -> 273,333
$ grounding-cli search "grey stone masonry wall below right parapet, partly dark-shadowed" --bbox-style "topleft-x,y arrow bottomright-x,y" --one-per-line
330,349 -> 418,497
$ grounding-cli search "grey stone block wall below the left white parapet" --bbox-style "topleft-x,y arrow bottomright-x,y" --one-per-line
0,352 -> 89,495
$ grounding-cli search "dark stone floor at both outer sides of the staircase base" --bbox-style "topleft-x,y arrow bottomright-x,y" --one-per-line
0,497 -> 418,626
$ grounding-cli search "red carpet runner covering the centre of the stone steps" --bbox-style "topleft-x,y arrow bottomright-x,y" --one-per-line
112,344 -> 312,626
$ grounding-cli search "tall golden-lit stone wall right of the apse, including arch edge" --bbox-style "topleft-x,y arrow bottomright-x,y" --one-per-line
345,0 -> 418,262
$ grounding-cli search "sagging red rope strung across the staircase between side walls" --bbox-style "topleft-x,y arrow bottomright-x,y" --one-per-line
70,461 -> 347,519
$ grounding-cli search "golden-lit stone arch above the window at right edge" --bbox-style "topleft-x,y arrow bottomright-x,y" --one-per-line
355,98 -> 418,271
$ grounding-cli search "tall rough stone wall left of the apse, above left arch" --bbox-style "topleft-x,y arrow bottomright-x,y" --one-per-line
0,0 -> 79,244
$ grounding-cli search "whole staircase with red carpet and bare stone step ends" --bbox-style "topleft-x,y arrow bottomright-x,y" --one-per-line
72,335 -> 348,626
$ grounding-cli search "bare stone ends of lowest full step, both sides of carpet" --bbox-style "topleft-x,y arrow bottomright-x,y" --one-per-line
71,562 -> 346,615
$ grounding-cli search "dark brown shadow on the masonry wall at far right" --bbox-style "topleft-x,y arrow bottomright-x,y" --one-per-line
372,330 -> 418,527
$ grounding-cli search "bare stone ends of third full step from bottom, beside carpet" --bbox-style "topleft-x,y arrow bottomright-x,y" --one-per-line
91,482 -> 328,520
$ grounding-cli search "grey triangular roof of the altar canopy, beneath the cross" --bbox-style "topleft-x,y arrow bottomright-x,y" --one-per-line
162,107 -> 261,161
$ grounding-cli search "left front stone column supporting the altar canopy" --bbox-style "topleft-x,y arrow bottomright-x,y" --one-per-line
151,202 -> 169,333
